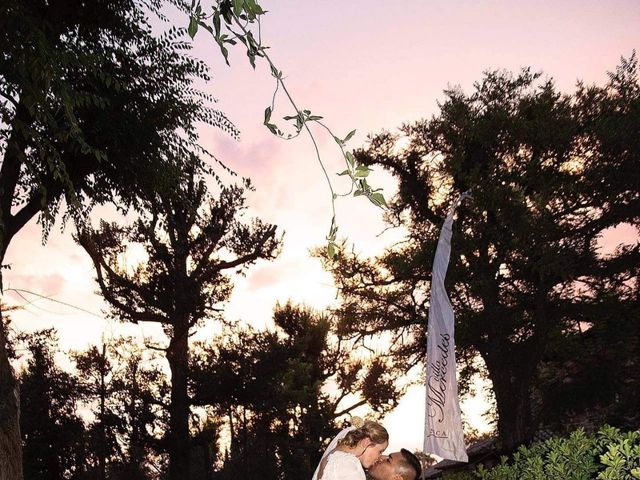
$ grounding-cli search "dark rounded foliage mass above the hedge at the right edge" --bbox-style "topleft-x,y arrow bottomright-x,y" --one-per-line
533,288 -> 640,433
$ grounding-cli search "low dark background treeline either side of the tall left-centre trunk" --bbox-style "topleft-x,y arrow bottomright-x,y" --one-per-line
12,304 -> 398,480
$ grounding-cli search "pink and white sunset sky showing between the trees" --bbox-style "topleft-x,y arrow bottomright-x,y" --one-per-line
5,0 -> 640,450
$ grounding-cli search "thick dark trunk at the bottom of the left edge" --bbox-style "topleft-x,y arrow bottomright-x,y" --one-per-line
0,308 -> 22,480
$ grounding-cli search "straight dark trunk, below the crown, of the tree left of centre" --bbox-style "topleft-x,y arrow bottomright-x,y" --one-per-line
167,324 -> 190,480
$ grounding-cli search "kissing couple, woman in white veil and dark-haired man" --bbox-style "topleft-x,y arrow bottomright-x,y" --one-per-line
313,417 -> 422,480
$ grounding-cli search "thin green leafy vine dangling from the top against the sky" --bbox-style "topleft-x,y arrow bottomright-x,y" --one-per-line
188,0 -> 387,257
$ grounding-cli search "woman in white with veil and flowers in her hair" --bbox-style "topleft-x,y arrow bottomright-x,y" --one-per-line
313,418 -> 389,480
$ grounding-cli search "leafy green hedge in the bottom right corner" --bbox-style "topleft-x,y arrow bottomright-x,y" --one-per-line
443,426 -> 640,480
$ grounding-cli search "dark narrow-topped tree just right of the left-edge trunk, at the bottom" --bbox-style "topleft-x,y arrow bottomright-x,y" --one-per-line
20,329 -> 87,480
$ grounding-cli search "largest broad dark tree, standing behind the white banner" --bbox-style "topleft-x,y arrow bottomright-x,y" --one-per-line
327,54 -> 640,449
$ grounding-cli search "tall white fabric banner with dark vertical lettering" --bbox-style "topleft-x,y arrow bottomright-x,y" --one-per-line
424,192 -> 470,462
